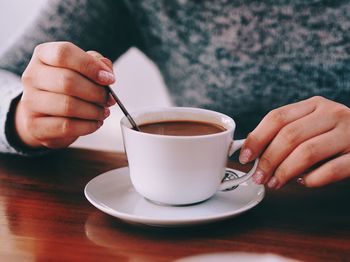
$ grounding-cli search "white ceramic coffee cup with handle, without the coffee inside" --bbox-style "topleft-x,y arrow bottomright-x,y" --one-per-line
121,107 -> 259,205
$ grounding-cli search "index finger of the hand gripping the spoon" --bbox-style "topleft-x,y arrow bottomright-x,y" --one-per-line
34,42 -> 115,85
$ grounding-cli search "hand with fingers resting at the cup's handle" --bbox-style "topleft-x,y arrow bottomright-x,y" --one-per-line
240,97 -> 350,189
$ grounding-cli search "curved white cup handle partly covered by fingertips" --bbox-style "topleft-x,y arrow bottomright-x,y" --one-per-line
219,139 -> 259,191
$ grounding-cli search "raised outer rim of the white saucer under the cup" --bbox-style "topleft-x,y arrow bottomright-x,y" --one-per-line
84,166 -> 266,227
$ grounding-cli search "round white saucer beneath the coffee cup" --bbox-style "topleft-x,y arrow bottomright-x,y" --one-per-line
84,167 -> 265,227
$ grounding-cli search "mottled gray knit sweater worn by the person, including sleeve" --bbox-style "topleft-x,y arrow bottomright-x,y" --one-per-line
0,0 -> 350,155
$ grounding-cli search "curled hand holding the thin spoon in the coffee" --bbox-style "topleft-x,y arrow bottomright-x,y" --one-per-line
15,42 -> 115,148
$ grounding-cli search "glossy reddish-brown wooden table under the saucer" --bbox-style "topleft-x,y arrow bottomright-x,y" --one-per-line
0,149 -> 350,261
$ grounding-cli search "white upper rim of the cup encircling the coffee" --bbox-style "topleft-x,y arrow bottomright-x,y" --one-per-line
120,106 -> 236,139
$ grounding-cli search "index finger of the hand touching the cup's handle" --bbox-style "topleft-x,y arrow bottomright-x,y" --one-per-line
239,98 -> 316,164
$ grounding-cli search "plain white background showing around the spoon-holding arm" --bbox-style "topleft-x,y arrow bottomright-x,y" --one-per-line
0,0 -> 171,151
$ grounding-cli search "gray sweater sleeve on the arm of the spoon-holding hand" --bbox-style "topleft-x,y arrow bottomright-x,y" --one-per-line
0,0 -> 140,155
